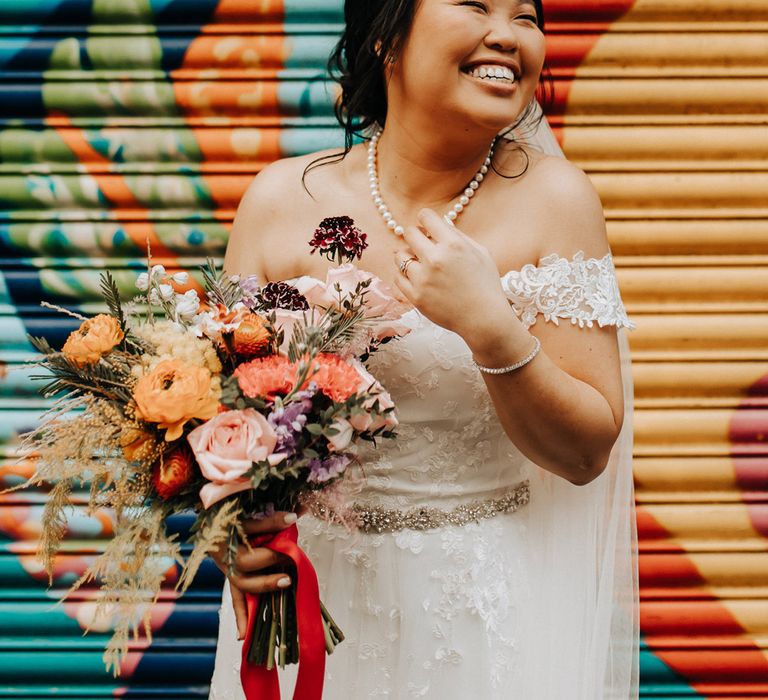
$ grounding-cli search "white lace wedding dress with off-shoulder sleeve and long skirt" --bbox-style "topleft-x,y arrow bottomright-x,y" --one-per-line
210,254 -> 637,700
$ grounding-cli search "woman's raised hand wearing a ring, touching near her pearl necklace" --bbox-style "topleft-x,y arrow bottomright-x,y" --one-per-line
395,209 -> 510,338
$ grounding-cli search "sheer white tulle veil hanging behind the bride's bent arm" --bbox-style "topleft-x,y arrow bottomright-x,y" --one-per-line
504,100 -> 640,700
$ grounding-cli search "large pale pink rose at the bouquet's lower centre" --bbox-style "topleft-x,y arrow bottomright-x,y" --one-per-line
187,408 -> 285,508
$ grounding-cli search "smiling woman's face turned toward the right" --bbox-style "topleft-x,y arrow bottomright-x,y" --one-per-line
389,0 -> 545,132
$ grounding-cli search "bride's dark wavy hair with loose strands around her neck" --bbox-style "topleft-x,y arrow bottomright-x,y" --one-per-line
301,0 -> 554,191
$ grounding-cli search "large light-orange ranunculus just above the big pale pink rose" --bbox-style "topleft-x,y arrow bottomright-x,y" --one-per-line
133,359 -> 219,442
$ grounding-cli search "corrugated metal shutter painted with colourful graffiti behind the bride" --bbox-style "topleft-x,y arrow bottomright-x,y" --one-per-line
0,0 -> 768,699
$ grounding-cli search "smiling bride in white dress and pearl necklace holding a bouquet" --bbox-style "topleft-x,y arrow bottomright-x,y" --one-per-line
210,0 -> 638,700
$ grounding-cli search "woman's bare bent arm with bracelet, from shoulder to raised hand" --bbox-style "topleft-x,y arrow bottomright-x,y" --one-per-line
398,159 -> 624,484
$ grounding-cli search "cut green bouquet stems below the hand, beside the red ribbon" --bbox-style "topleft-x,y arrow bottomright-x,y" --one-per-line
248,585 -> 344,670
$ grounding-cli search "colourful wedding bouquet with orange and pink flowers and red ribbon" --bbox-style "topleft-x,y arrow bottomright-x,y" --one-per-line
10,217 -> 407,696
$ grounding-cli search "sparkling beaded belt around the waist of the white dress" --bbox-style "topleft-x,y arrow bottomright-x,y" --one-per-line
310,481 -> 531,533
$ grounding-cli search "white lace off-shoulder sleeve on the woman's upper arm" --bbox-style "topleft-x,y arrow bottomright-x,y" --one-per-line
501,251 -> 636,330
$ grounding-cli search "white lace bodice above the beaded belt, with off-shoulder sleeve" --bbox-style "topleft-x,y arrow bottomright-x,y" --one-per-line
344,251 -> 635,508
